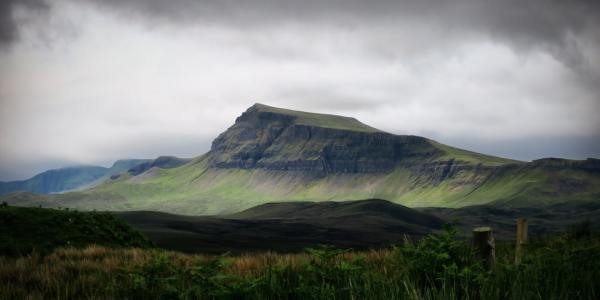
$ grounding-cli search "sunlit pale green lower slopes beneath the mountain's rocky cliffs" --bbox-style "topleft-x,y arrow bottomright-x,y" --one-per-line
8,157 -> 600,215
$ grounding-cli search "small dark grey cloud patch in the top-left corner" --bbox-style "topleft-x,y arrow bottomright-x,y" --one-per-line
0,0 -> 50,50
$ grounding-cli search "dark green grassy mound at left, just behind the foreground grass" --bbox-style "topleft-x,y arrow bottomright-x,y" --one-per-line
0,206 -> 152,255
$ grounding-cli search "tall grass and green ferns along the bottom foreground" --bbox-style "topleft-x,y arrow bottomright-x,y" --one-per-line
0,227 -> 600,299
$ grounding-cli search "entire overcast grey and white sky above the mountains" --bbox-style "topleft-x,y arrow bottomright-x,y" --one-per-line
0,0 -> 600,180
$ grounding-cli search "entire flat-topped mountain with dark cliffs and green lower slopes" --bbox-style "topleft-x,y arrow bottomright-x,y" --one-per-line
1,104 -> 600,215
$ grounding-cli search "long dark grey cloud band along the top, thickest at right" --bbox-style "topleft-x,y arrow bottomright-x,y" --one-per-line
85,0 -> 600,68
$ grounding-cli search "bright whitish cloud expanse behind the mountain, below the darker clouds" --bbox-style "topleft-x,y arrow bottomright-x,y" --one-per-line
0,2 -> 600,179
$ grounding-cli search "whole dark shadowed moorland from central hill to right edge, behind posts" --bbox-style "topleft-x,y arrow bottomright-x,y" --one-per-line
115,199 -> 600,253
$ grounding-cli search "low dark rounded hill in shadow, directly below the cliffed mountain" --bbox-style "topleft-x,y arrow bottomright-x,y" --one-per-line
116,199 -> 444,253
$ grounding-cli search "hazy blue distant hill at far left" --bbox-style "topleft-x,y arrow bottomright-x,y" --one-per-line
0,159 -> 149,195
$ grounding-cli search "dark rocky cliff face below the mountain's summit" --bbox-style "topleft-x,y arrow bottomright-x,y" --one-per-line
209,104 -> 439,174
